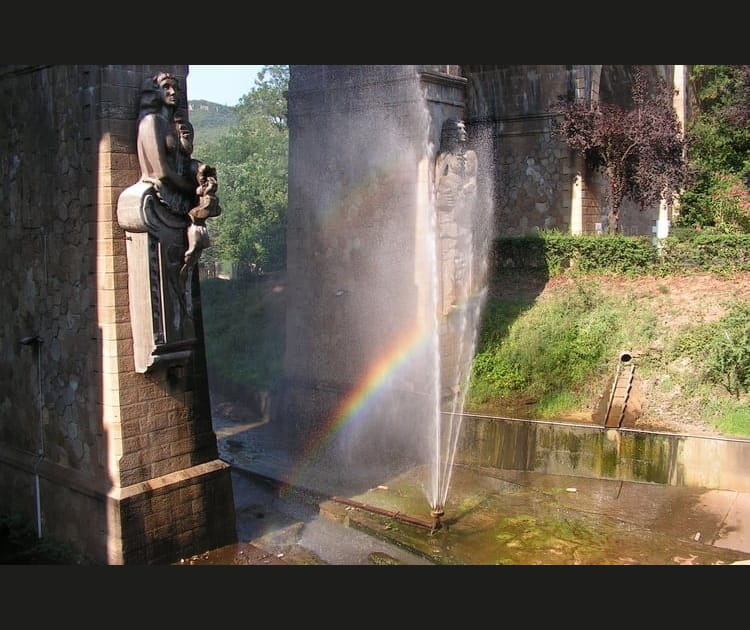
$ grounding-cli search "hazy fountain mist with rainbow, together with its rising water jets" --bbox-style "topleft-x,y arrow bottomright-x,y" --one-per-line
277,66 -> 492,520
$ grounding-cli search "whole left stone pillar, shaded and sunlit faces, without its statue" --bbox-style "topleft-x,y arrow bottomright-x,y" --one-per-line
0,65 -> 234,564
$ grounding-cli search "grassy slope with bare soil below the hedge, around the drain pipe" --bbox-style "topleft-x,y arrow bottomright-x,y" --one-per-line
469,273 -> 750,437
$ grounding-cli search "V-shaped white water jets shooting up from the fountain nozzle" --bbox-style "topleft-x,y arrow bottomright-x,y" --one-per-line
426,106 -> 492,516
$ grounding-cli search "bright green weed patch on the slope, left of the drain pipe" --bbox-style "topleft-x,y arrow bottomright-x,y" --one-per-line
468,278 -> 656,418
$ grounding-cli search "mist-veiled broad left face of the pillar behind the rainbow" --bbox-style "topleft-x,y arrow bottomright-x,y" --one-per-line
271,66 -> 465,478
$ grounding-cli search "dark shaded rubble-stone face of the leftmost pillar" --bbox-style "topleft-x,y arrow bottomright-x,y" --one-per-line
0,66 -> 109,555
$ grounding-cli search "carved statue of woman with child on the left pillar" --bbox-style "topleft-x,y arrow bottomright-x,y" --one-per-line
117,72 -> 221,373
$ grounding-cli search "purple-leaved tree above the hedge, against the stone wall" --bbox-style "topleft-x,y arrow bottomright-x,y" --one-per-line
552,67 -> 687,234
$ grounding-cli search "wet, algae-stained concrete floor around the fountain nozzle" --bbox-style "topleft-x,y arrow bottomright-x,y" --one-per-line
182,418 -> 750,565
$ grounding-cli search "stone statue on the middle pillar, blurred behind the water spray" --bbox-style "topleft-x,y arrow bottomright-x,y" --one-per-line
435,118 -> 477,315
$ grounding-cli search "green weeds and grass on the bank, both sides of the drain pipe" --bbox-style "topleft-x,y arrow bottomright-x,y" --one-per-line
467,275 -> 750,437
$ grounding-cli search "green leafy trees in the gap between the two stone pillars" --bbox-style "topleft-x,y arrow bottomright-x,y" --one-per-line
195,66 -> 289,271
